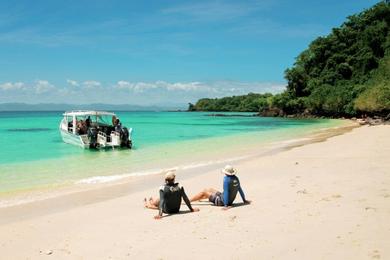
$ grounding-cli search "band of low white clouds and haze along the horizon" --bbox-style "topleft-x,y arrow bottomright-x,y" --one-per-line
0,79 -> 286,105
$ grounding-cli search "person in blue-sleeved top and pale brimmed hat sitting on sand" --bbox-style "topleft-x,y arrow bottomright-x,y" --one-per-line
190,165 -> 251,209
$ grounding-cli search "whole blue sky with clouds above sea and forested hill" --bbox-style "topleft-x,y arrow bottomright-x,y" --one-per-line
0,0 -> 378,106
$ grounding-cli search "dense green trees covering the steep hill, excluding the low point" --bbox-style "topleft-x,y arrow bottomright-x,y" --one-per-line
281,2 -> 390,116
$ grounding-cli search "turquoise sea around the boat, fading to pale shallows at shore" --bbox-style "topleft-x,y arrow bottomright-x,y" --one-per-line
0,112 -> 340,194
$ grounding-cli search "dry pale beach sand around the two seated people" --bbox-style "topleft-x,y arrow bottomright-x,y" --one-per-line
0,125 -> 390,259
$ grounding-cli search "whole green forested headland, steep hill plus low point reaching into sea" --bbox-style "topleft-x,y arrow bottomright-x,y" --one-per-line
188,1 -> 390,117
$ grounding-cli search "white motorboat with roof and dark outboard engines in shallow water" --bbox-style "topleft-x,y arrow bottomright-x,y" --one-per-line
59,110 -> 133,148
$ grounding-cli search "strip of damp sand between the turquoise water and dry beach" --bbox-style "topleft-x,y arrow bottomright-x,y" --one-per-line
0,121 -> 360,221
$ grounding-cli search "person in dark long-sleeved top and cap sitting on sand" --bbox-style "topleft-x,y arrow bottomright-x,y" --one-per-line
145,171 -> 199,219
